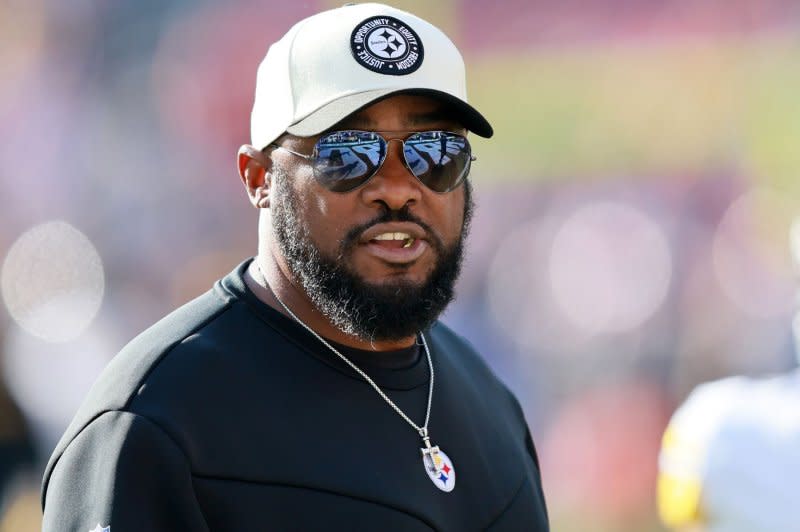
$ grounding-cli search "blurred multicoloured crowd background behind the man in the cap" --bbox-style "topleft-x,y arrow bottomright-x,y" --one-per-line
0,0 -> 800,532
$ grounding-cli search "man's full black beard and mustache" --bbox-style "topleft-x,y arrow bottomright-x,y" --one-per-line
270,163 -> 474,341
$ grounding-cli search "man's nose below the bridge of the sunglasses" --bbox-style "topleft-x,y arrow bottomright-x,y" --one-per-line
362,139 -> 424,210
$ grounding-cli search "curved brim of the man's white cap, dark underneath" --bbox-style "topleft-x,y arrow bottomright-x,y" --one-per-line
286,89 -> 494,138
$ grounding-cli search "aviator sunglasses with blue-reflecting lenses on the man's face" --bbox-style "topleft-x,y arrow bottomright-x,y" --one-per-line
270,130 -> 475,192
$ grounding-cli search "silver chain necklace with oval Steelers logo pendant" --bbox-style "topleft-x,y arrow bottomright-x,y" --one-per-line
256,263 -> 456,492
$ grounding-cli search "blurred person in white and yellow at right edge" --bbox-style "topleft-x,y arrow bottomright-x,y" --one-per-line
658,219 -> 800,532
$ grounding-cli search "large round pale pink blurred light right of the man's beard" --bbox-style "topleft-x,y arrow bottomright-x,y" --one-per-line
549,202 -> 672,334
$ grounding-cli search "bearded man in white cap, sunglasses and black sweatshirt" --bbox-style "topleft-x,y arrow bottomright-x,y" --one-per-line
43,4 -> 548,532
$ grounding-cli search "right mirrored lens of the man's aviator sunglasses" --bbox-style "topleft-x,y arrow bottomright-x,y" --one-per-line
404,131 -> 471,192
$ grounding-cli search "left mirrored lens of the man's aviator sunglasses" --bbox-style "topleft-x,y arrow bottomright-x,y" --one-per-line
314,131 -> 386,192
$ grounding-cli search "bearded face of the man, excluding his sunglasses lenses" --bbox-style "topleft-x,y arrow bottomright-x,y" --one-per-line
271,95 -> 471,340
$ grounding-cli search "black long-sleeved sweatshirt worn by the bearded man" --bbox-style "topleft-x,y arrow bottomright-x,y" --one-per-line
42,261 -> 549,532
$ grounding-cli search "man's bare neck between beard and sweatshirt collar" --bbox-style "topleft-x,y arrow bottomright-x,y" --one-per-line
245,252 -> 416,352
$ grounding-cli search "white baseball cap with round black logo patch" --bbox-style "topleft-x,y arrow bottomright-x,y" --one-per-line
250,4 -> 493,149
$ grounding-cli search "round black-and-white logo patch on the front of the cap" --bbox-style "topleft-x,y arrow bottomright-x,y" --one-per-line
350,16 -> 424,76
